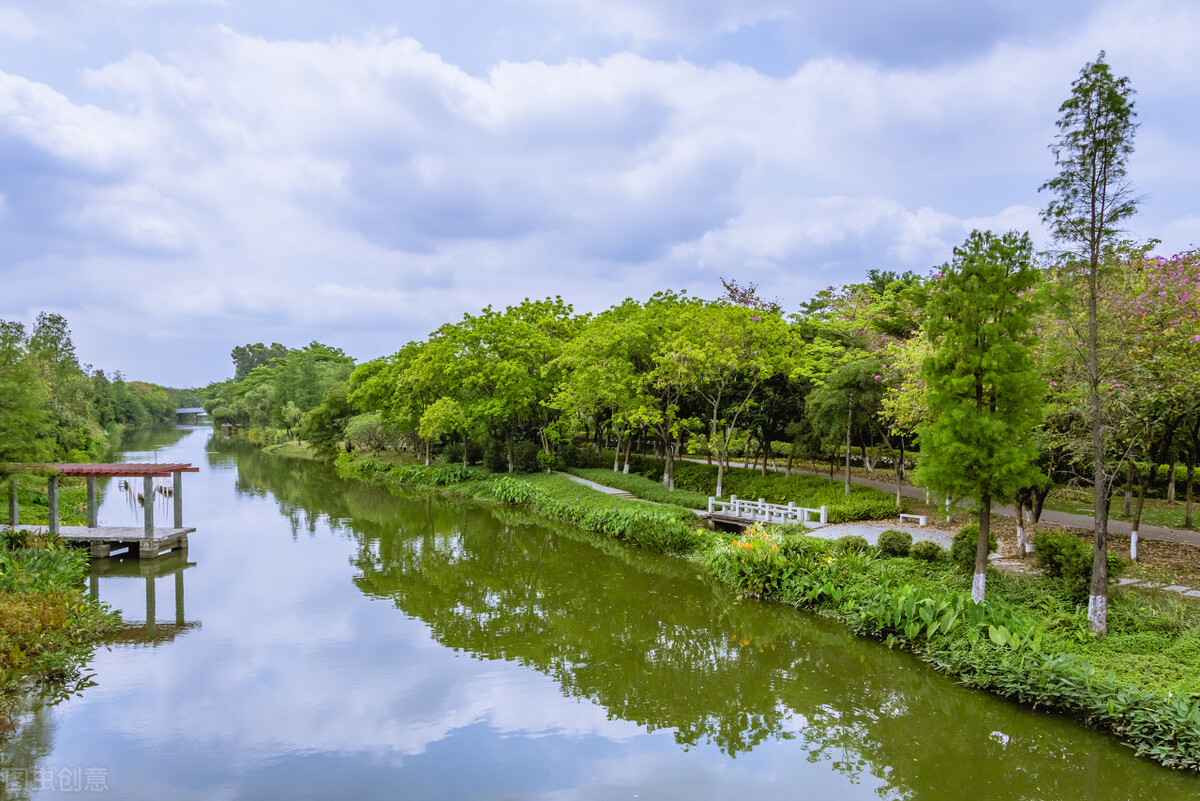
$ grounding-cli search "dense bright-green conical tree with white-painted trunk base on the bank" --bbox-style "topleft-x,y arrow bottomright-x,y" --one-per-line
917,231 -> 1045,601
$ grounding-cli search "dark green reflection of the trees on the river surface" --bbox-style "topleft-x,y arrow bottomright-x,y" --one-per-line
229,453 -> 1196,799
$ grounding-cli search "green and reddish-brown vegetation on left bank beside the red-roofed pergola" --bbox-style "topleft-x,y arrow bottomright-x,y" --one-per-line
0,477 -> 119,735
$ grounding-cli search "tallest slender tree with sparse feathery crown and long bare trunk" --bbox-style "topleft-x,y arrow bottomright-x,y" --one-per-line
1042,50 -> 1138,634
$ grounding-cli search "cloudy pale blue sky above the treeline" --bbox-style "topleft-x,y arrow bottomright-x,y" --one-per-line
0,0 -> 1200,387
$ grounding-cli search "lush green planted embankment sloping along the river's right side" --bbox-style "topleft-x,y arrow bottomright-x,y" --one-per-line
328,457 -> 1200,771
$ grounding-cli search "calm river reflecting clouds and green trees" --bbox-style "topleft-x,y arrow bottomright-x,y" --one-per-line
0,427 -> 1200,801
